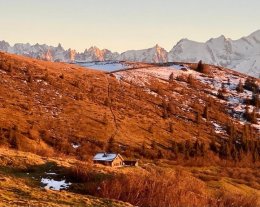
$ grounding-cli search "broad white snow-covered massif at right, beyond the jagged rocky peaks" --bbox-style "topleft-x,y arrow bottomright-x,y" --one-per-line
168,30 -> 260,77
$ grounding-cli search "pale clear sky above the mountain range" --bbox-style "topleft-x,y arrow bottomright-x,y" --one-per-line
0,0 -> 260,52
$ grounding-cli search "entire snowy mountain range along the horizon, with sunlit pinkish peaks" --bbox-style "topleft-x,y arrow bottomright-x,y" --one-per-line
0,30 -> 260,77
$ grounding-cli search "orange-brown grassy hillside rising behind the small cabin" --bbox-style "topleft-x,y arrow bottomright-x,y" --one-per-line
0,53 -> 259,160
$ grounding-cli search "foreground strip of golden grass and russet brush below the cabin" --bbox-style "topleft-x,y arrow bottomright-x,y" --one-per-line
0,148 -> 258,207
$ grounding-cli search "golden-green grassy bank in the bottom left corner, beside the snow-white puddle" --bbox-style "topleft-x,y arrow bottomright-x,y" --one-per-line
0,148 -> 132,207
